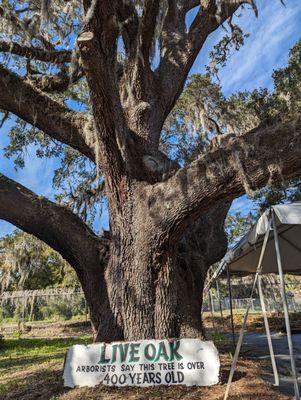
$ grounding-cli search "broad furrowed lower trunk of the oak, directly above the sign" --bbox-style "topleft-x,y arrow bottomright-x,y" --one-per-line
92,186 -> 229,342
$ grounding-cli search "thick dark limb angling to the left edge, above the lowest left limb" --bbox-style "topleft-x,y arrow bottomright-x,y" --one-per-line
0,66 -> 95,161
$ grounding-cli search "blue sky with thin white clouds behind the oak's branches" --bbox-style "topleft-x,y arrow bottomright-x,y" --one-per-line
0,0 -> 301,236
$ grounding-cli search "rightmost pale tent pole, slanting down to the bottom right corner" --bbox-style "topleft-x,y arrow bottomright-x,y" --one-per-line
272,211 -> 300,400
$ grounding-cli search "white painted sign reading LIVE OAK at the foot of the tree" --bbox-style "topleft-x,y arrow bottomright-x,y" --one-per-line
64,339 -> 220,387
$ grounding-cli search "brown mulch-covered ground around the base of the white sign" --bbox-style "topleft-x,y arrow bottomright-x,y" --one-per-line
0,354 -> 289,400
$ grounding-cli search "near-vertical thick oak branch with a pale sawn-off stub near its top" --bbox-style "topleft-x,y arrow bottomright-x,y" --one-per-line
77,1 -> 127,184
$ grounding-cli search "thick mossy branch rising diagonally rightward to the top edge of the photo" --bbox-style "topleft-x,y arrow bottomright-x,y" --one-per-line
157,0 -> 244,127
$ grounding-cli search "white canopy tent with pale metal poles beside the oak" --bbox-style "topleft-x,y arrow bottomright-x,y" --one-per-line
207,202 -> 301,400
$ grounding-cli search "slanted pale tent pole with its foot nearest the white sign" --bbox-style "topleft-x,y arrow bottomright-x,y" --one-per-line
224,218 -> 272,400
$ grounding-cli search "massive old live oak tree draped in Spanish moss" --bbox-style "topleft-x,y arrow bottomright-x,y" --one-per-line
0,0 -> 301,341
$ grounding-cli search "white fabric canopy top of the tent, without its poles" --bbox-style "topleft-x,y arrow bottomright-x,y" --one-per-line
220,202 -> 301,274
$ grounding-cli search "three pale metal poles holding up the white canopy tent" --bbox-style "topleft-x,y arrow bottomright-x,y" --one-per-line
224,209 -> 300,400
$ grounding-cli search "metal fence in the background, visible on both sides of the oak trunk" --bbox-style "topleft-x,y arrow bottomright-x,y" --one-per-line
0,288 -> 301,332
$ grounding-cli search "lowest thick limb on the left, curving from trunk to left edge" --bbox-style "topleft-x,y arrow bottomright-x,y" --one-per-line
0,173 -> 109,270
